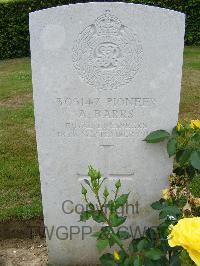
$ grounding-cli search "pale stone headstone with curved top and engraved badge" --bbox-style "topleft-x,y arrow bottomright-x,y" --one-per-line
30,2 -> 185,265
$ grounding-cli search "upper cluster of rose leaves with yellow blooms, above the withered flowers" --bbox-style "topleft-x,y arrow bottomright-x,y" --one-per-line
145,120 -> 200,177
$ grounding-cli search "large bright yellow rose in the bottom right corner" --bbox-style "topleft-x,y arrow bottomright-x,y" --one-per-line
168,217 -> 200,266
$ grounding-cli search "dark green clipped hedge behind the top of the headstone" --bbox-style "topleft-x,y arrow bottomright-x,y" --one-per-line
0,0 -> 200,59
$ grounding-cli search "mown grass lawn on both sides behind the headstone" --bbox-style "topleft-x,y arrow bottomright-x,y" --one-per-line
0,47 -> 200,221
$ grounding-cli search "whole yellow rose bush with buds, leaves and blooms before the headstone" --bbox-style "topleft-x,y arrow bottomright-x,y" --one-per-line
80,120 -> 200,266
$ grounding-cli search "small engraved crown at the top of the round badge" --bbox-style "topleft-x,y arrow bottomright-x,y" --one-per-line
95,10 -> 122,35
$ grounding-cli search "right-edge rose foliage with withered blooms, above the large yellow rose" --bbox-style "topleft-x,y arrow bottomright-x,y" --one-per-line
145,120 -> 200,217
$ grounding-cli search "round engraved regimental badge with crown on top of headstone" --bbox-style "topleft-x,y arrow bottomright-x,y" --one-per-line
72,10 -> 143,90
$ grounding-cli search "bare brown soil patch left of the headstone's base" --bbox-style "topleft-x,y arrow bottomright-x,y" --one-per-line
0,236 -> 47,266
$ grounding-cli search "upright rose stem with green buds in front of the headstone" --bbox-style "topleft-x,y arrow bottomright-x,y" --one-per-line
80,166 -> 130,254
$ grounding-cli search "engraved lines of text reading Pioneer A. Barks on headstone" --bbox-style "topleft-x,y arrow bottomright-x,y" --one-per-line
56,97 -> 157,138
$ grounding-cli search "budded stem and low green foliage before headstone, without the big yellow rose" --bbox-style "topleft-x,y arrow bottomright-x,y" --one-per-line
80,166 -> 181,266
